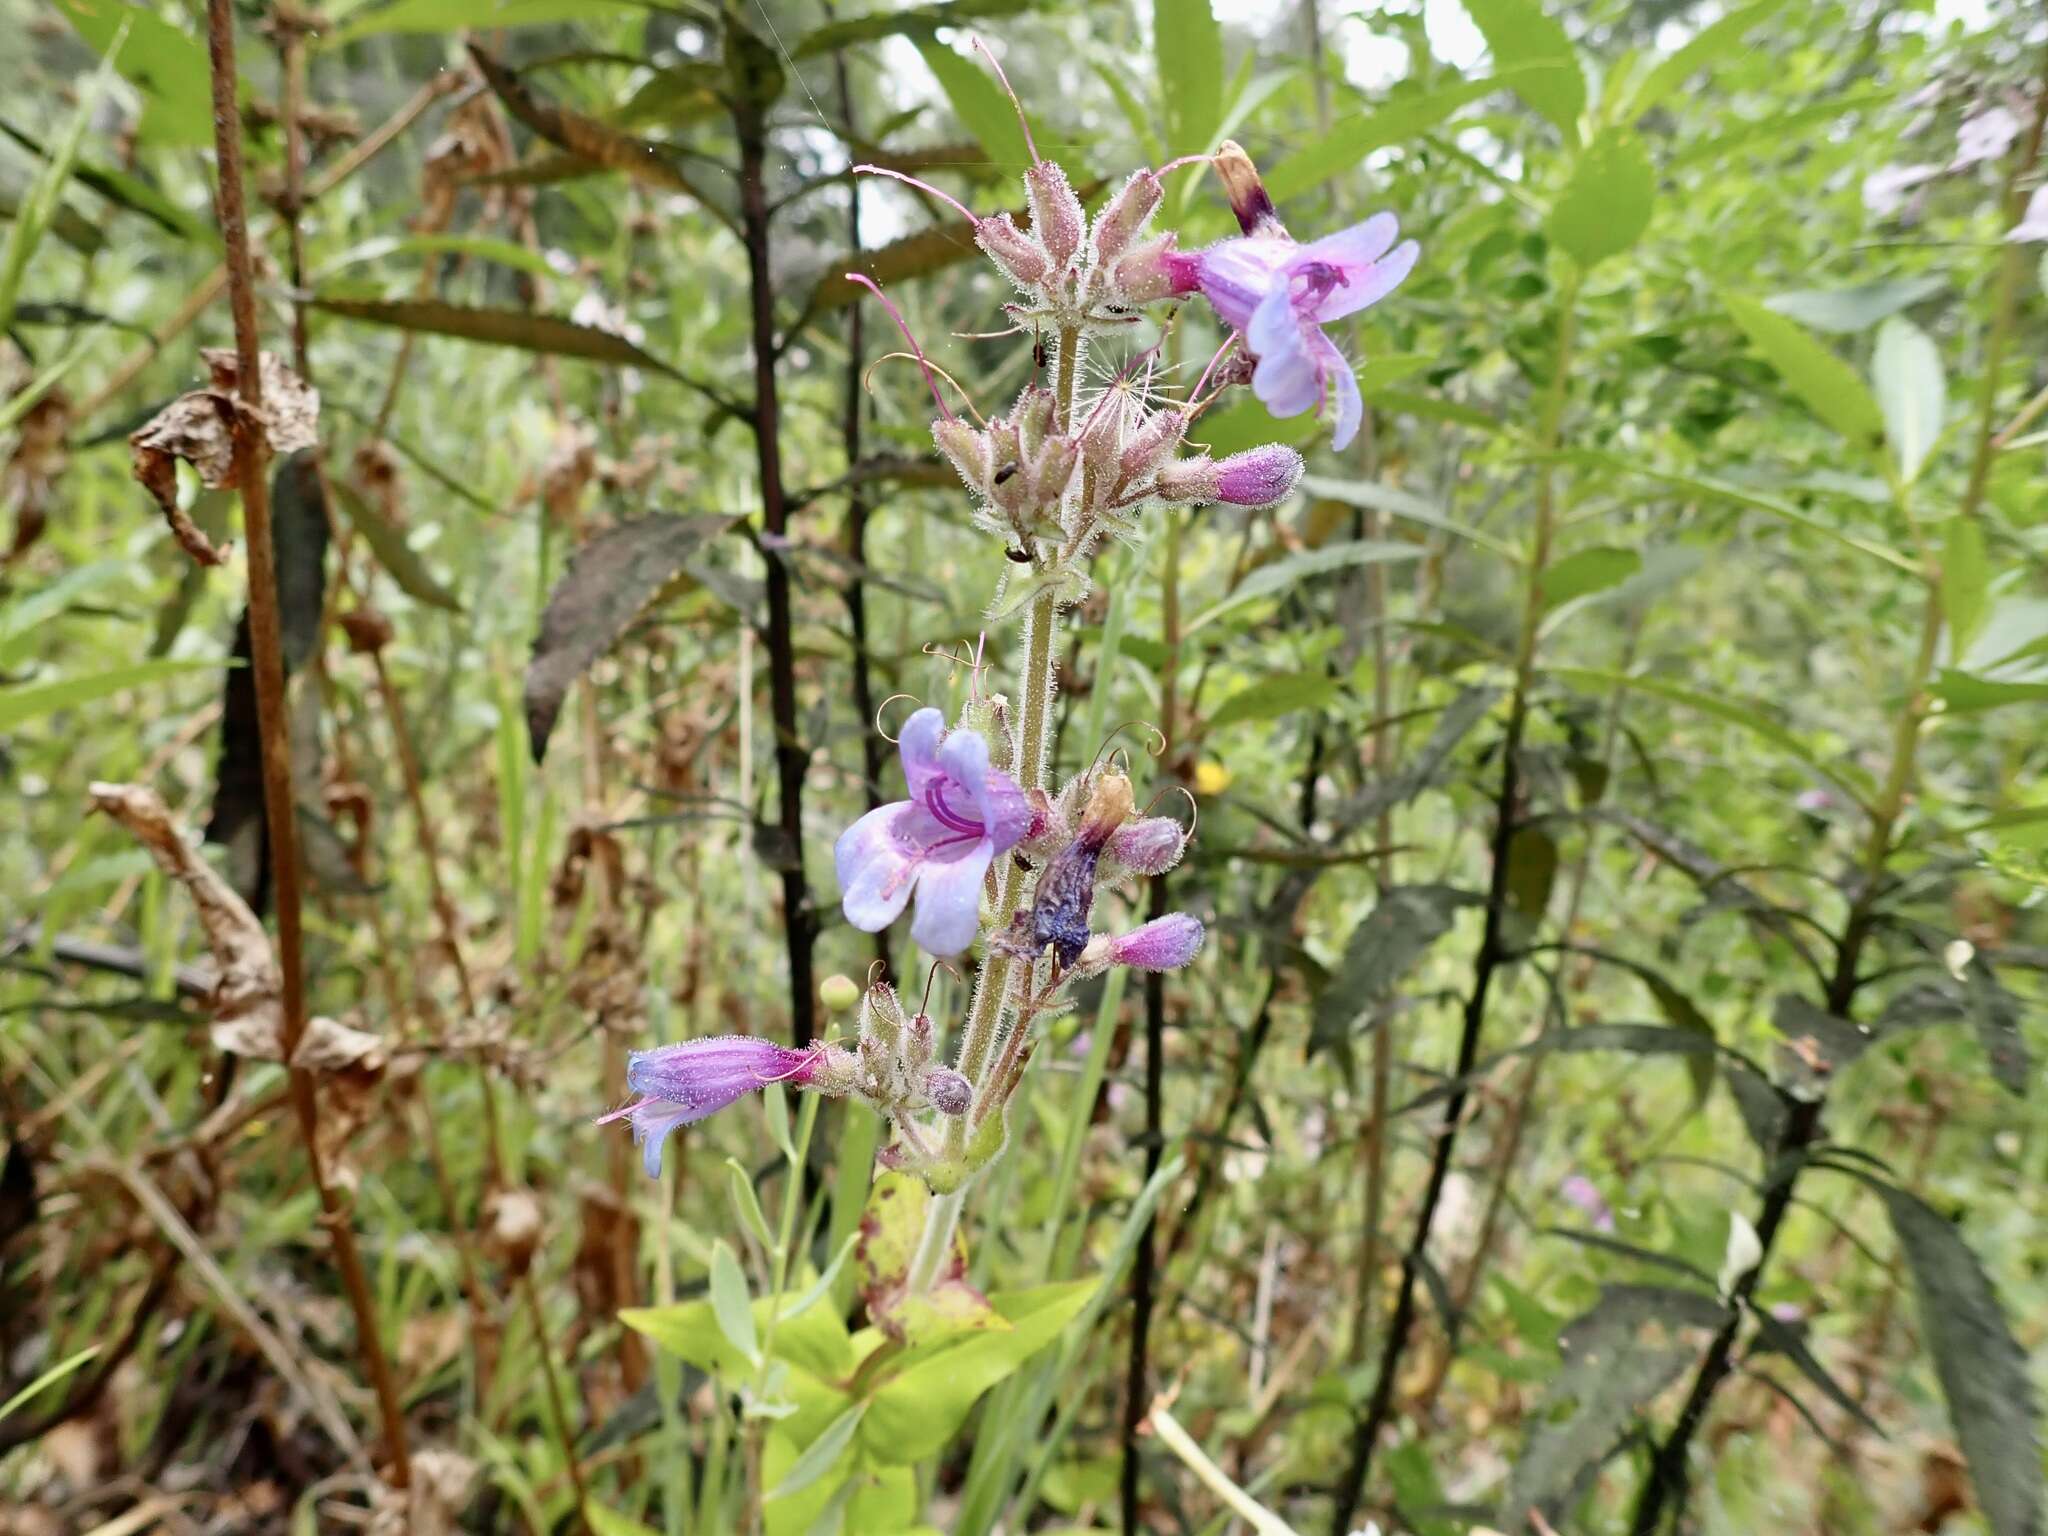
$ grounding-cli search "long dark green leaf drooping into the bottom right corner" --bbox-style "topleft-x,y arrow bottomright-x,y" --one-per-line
1872,1180 -> 2044,1536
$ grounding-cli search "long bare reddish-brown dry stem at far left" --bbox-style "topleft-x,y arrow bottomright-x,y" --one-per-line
207,0 -> 412,1489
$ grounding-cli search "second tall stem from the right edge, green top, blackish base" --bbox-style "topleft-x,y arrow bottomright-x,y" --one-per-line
1329,268 -> 1579,1536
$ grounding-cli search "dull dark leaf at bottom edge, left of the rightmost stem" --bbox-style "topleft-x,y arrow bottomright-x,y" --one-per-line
1503,1286 -> 1729,1532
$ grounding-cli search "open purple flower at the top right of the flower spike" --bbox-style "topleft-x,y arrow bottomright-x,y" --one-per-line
1167,213 -> 1419,449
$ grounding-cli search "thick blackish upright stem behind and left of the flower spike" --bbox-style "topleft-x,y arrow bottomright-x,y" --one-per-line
733,83 -> 817,1049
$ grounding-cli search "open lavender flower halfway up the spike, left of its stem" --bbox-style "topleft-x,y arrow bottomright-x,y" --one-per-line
831,709 -> 1030,954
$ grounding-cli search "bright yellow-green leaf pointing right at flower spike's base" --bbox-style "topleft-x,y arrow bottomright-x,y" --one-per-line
860,1280 -> 1096,1466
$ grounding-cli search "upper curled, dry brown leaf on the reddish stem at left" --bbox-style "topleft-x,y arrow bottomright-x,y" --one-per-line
129,346 -> 319,565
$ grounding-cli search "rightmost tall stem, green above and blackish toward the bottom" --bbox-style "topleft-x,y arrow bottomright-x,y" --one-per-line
1630,69 -> 2048,1536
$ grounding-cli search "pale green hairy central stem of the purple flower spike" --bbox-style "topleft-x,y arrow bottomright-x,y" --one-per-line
907,330 -> 1083,1296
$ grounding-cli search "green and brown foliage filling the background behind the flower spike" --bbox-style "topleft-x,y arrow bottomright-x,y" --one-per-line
0,0 -> 2048,1536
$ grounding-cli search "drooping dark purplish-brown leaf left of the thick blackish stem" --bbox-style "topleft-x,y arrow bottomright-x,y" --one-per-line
526,516 -> 731,762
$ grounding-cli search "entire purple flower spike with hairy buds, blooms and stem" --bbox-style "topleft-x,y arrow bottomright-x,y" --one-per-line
604,99 -> 1415,1204
